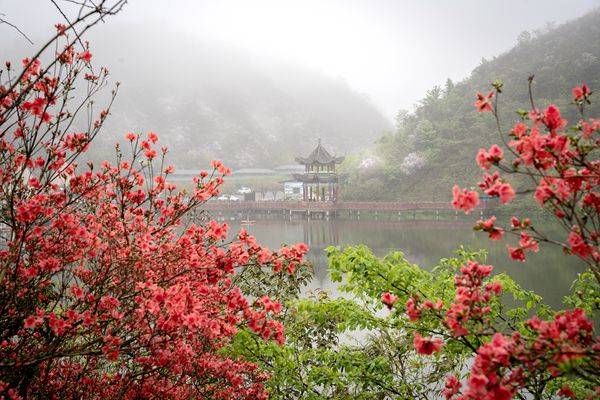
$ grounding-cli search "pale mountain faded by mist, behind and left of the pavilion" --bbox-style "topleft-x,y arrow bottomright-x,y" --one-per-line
84,24 -> 390,168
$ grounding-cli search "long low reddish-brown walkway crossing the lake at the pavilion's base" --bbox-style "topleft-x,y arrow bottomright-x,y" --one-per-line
203,201 -> 488,214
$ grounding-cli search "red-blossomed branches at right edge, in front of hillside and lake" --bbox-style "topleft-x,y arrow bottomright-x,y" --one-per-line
453,78 -> 600,282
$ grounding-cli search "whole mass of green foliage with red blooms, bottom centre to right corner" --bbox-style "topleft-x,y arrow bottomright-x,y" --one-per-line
232,246 -> 600,399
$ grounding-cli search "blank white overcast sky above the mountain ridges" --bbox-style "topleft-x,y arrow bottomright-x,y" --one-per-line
0,0 -> 600,118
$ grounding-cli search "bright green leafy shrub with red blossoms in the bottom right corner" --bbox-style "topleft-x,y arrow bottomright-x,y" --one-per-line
329,247 -> 600,400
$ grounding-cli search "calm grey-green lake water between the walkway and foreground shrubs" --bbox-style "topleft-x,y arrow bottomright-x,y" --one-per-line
229,219 -> 585,308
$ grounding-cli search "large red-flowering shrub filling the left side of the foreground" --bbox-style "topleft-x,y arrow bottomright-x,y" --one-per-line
0,18 -> 307,399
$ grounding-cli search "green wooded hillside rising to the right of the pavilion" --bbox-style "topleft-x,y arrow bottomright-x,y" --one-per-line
343,10 -> 600,200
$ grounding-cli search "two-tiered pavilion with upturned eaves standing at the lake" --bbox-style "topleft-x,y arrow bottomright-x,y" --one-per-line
293,139 -> 344,201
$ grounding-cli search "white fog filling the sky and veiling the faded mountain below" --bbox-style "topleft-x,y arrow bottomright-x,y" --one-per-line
0,0 -> 600,168
